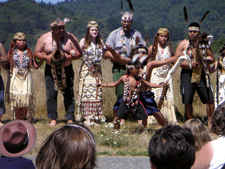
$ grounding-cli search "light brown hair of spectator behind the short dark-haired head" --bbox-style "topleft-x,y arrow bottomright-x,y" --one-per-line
183,119 -> 211,152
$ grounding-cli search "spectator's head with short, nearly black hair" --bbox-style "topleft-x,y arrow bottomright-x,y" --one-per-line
148,125 -> 195,169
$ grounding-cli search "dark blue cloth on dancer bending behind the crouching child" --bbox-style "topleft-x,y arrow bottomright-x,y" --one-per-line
139,91 -> 160,115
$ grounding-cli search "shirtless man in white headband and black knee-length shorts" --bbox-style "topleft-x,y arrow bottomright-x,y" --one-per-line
175,23 -> 215,125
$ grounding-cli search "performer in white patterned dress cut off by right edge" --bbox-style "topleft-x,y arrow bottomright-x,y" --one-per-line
207,44 -> 225,109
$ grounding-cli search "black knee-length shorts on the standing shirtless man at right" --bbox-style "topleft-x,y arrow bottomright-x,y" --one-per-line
180,69 -> 214,104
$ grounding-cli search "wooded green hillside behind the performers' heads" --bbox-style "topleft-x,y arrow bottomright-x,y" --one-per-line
0,0 -> 225,55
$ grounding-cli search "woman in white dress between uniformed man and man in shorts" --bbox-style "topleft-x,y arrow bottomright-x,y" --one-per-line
148,28 -> 177,124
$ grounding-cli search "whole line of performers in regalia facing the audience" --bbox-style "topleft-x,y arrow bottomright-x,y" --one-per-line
0,0 -> 225,130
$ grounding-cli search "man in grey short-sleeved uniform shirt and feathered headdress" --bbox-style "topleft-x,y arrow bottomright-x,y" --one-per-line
106,0 -> 145,117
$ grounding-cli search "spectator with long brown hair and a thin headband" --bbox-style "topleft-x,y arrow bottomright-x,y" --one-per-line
36,124 -> 96,169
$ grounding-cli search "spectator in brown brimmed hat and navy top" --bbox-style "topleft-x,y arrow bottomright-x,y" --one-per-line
0,120 -> 36,169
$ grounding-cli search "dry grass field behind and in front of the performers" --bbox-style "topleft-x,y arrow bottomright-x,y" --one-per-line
1,60 -> 215,156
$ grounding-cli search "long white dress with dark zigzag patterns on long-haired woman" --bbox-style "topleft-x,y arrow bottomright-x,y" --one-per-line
76,43 -> 106,122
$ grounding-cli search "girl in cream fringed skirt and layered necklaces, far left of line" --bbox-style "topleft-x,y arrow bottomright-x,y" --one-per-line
5,32 -> 42,122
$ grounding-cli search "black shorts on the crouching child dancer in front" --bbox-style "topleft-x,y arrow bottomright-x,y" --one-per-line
116,100 -> 148,120
